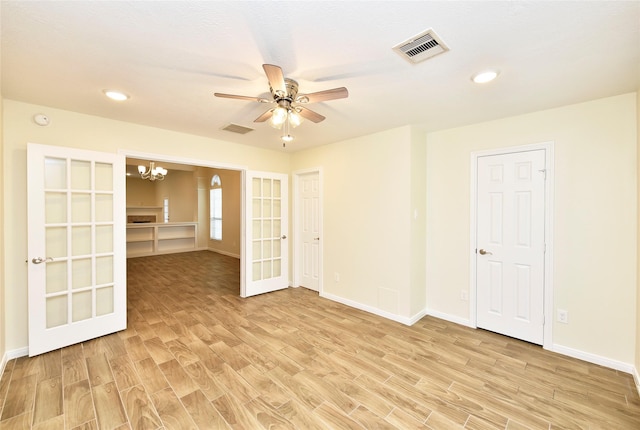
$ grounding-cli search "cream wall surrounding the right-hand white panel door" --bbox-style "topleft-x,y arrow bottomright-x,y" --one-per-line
426,93 -> 638,365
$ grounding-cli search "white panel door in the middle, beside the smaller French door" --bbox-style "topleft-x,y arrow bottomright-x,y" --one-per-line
298,172 -> 320,291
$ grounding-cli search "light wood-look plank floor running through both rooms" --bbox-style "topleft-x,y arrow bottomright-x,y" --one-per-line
0,252 -> 640,430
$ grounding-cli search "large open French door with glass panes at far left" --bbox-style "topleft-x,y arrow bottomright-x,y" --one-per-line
27,144 -> 127,356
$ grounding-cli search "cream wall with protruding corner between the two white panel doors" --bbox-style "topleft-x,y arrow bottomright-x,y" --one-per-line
292,127 -> 425,321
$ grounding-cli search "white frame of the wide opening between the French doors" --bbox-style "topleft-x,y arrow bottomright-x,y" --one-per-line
118,149 -> 249,292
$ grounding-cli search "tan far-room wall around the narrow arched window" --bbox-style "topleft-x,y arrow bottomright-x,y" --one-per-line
207,169 -> 242,258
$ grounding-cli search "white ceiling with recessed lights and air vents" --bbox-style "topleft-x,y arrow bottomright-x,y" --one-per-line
0,0 -> 640,151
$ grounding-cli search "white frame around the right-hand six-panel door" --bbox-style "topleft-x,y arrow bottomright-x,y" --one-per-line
469,142 -> 554,350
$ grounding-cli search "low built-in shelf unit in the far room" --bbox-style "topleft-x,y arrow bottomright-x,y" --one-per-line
127,222 -> 198,257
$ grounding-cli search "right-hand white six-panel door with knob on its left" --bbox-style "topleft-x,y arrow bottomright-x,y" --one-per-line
476,149 -> 546,344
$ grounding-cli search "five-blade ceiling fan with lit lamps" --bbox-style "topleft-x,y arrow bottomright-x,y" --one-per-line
213,64 -> 349,141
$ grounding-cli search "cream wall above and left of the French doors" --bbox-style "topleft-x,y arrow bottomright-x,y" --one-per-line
3,99 -> 291,351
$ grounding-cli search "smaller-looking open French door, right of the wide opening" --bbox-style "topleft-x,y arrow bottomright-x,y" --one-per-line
240,171 -> 289,297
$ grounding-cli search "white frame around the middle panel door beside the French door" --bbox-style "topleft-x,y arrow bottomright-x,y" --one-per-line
291,167 -> 324,296
